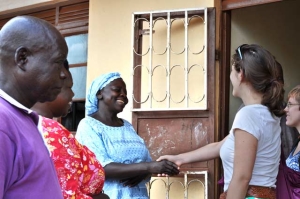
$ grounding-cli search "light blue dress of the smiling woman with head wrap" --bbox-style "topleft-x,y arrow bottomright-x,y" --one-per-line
76,116 -> 152,199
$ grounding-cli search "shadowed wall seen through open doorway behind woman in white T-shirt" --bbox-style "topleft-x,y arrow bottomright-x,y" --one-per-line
228,0 -> 300,127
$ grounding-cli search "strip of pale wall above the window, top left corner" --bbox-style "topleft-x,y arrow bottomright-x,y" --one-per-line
0,0 -> 67,15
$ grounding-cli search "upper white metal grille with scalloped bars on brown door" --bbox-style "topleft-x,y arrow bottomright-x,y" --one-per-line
132,8 -> 207,111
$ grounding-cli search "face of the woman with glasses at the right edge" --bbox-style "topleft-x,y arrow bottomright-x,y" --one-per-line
284,97 -> 300,129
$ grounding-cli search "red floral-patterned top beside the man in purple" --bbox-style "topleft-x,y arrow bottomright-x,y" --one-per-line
41,117 -> 105,199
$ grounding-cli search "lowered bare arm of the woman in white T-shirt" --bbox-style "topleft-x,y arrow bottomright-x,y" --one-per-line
227,129 -> 258,199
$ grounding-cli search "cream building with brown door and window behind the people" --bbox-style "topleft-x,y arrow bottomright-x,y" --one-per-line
0,0 -> 300,199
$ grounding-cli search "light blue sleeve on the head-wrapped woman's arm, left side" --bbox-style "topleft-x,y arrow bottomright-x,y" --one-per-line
75,119 -> 114,167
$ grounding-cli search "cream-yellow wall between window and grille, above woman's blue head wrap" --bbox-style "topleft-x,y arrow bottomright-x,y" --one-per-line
87,0 -> 214,121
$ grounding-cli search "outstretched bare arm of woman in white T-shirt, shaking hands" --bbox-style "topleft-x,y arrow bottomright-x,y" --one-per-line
157,136 -> 227,167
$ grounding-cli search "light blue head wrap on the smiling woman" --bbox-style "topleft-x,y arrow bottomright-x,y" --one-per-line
85,72 -> 121,115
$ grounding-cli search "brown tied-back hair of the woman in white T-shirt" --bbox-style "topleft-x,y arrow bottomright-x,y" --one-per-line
233,44 -> 284,117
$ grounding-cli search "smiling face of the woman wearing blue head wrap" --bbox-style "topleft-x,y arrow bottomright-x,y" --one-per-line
98,78 -> 128,113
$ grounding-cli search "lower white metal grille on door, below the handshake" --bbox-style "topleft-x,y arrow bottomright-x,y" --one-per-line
148,171 -> 208,199
